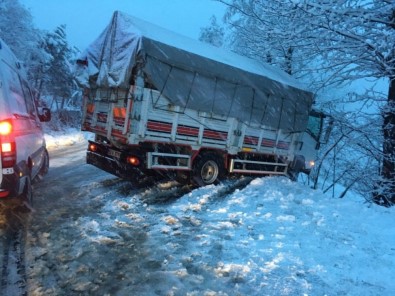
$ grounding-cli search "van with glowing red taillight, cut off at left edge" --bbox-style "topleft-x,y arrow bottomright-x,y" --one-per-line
0,39 -> 51,207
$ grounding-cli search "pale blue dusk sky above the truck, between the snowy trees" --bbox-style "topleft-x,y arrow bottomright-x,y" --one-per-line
19,0 -> 225,51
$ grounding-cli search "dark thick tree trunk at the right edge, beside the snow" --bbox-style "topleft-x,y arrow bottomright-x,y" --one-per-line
373,77 -> 395,206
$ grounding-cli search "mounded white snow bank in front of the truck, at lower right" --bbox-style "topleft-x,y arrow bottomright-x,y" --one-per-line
140,178 -> 395,295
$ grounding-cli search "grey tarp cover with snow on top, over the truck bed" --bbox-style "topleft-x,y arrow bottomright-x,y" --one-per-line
76,11 -> 313,131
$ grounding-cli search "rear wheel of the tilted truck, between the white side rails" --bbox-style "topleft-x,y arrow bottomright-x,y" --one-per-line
193,154 -> 224,186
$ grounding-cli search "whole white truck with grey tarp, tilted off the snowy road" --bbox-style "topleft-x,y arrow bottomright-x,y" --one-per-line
76,12 -> 323,186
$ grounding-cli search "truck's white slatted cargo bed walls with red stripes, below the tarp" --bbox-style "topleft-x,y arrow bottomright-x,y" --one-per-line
83,88 -> 298,158
